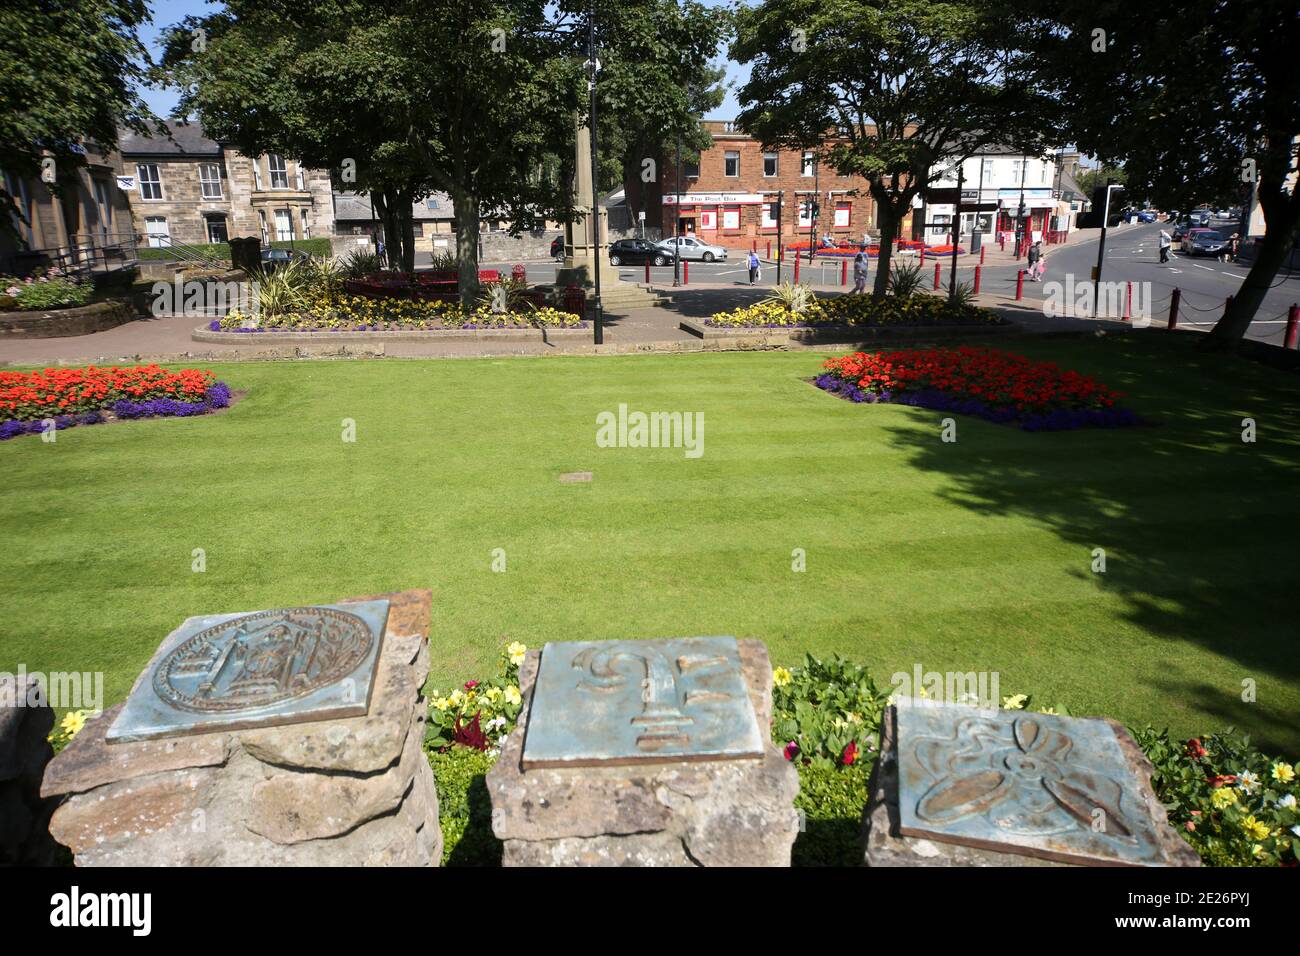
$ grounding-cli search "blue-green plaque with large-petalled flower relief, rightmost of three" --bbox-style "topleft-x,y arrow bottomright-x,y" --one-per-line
897,705 -> 1165,866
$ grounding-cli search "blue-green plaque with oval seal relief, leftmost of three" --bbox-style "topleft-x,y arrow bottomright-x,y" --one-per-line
105,601 -> 389,744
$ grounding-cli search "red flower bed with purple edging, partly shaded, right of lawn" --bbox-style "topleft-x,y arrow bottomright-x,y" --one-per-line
814,346 -> 1141,431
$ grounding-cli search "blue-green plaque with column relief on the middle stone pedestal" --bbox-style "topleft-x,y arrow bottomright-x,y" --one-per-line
521,637 -> 763,770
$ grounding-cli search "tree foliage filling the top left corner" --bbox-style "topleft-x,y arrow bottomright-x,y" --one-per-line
0,0 -> 153,247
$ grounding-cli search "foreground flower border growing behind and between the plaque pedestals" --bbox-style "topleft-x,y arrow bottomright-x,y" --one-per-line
410,643 -> 1300,866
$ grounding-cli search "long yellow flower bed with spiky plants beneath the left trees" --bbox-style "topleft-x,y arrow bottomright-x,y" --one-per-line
208,295 -> 586,333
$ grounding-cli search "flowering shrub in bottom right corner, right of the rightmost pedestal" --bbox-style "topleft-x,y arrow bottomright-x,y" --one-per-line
1134,727 -> 1300,866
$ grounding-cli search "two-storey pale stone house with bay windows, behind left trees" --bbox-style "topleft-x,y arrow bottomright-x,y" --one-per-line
118,122 -> 334,246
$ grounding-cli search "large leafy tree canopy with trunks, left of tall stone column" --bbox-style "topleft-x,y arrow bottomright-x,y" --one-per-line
164,0 -> 582,293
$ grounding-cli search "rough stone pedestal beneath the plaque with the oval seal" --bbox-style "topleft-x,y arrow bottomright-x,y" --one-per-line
42,591 -> 442,866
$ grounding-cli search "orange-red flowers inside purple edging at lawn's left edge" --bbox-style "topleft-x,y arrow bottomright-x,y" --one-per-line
0,365 -> 216,420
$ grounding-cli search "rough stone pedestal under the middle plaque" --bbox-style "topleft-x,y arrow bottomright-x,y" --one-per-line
488,640 -> 800,866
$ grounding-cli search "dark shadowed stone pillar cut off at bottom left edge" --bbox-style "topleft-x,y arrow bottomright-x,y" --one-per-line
0,674 -> 59,866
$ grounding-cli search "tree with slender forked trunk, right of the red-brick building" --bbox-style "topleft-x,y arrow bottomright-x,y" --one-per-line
732,0 -> 1047,295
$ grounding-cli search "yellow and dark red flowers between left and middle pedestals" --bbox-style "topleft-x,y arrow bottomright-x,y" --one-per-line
424,641 -> 528,756
